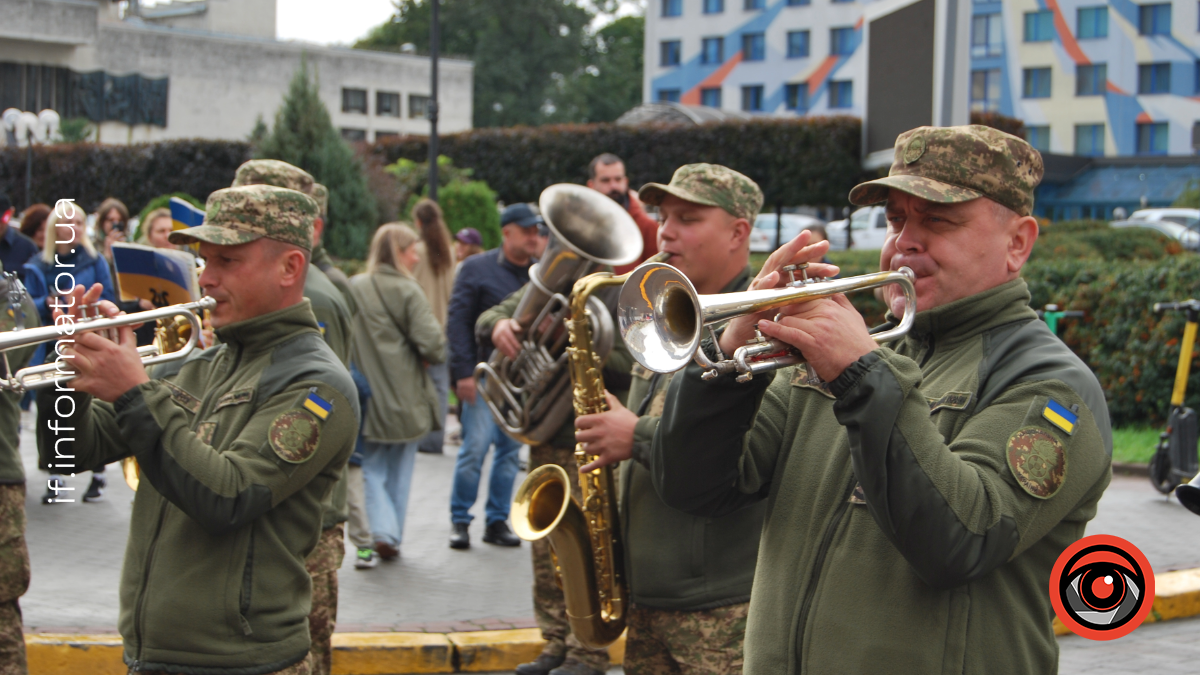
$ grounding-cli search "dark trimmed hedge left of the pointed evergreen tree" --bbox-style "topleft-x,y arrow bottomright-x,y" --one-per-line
0,141 -> 250,213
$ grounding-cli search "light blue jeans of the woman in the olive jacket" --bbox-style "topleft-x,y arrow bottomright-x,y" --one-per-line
362,441 -> 416,546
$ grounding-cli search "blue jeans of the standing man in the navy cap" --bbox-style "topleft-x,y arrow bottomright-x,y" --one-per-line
450,398 -> 521,525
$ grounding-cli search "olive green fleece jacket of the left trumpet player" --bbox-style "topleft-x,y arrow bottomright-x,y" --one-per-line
38,300 -> 359,675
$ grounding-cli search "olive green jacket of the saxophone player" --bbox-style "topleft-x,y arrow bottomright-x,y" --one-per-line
618,268 -> 767,610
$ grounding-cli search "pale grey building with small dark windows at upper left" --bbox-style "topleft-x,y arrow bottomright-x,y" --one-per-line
0,0 -> 474,143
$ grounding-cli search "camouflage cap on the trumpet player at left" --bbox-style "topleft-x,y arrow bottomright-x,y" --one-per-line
168,185 -> 317,251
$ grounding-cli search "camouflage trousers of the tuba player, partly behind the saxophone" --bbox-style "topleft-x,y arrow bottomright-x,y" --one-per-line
529,446 -> 608,670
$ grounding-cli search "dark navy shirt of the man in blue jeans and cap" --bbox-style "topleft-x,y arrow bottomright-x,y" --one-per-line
446,249 -> 532,382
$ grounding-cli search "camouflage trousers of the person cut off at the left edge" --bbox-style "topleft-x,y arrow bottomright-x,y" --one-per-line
0,484 -> 29,675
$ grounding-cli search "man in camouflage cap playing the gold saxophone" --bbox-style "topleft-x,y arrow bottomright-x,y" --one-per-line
564,165 -> 767,675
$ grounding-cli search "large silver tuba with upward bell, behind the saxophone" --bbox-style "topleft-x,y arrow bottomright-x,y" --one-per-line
475,184 -> 642,446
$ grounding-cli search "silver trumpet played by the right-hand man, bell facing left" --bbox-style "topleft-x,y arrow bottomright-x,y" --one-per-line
617,263 -> 917,382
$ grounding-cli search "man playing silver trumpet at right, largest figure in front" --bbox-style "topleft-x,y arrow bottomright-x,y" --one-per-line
650,126 -> 1112,674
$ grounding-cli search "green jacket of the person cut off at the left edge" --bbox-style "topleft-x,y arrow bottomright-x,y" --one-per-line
0,273 -> 41,485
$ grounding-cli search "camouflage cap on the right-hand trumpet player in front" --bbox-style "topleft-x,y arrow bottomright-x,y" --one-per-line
850,124 -> 1043,216
